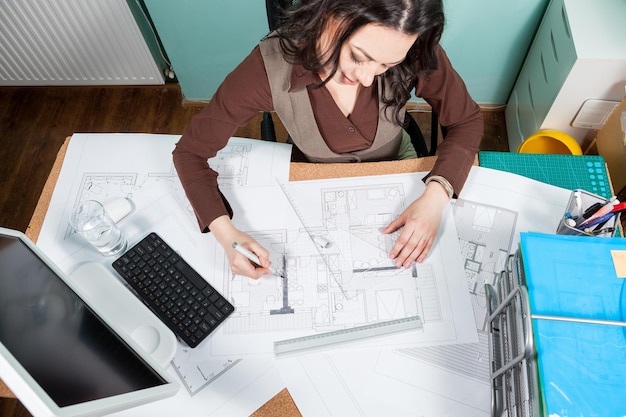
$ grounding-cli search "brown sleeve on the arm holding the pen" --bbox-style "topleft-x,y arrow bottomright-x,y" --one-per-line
173,46 -> 273,232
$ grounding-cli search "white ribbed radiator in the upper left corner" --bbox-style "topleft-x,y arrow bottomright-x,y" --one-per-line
0,0 -> 164,86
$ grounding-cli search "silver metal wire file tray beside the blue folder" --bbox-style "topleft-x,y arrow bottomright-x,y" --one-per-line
485,251 -> 540,417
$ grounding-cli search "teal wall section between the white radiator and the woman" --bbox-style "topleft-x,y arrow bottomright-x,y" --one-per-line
144,0 -> 268,100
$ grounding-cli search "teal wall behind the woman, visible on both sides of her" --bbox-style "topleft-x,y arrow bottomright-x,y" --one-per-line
144,0 -> 549,105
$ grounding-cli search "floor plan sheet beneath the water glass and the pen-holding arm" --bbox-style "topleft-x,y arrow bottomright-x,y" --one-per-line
37,134 -> 291,270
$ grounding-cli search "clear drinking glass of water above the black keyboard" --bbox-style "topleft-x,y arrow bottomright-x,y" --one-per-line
70,200 -> 128,256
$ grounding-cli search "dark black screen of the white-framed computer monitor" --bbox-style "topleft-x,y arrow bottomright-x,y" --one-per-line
0,234 -> 174,407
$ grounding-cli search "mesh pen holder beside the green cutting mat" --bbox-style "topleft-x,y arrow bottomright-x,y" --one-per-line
556,190 -> 619,237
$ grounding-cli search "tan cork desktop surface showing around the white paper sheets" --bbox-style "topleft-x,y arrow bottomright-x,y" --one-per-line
0,137 -> 454,417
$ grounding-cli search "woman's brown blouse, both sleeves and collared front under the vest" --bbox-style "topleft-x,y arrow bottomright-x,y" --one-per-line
173,46 -> 483,232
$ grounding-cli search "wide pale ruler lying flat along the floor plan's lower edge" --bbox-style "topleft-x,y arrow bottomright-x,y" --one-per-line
274,316 -> 424,356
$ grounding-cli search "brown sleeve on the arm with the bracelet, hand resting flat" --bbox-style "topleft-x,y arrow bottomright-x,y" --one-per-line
415,47 -> 484,195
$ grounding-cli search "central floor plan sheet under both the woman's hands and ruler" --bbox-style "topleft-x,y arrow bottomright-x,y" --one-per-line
211,175 -> 477,355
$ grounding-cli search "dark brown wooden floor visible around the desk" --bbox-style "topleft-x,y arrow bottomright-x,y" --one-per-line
0,84 -> 508,417
